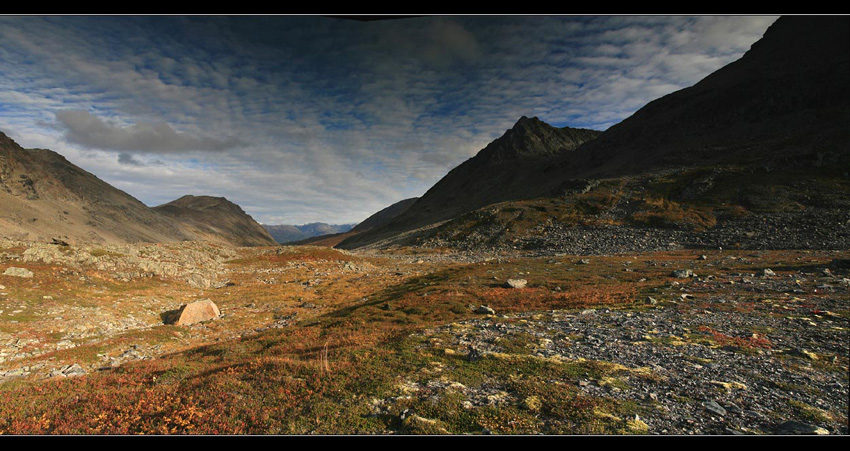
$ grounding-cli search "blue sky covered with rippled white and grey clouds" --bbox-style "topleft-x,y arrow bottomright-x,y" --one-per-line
0,15 -> 776,224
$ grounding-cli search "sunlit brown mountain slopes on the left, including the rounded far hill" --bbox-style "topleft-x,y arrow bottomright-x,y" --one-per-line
0,132 -> 275,246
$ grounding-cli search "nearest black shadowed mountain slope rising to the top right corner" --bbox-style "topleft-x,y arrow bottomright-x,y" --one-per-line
540,16 -> 850,183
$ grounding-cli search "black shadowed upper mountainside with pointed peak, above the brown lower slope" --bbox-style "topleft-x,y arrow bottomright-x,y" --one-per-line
339,16 -> 850,248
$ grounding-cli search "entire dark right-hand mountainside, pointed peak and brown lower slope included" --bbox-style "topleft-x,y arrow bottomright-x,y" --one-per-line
338,16 -> 850,249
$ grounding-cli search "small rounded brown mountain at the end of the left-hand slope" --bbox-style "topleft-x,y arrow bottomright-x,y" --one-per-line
153,195 -> 277,246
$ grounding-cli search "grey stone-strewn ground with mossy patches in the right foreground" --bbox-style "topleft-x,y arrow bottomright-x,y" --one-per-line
364,254 -> 850,435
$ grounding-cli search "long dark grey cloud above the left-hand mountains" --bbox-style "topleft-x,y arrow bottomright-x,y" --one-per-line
55,110 -> 242,155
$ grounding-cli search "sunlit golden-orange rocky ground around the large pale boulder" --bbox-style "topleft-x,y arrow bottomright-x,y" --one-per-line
0,240 -> 415,383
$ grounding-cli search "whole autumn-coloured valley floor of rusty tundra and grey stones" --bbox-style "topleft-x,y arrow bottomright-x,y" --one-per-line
0,241 -> 850,435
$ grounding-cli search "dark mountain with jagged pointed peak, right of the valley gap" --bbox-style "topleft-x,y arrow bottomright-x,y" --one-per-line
337,116 -> 601,249
